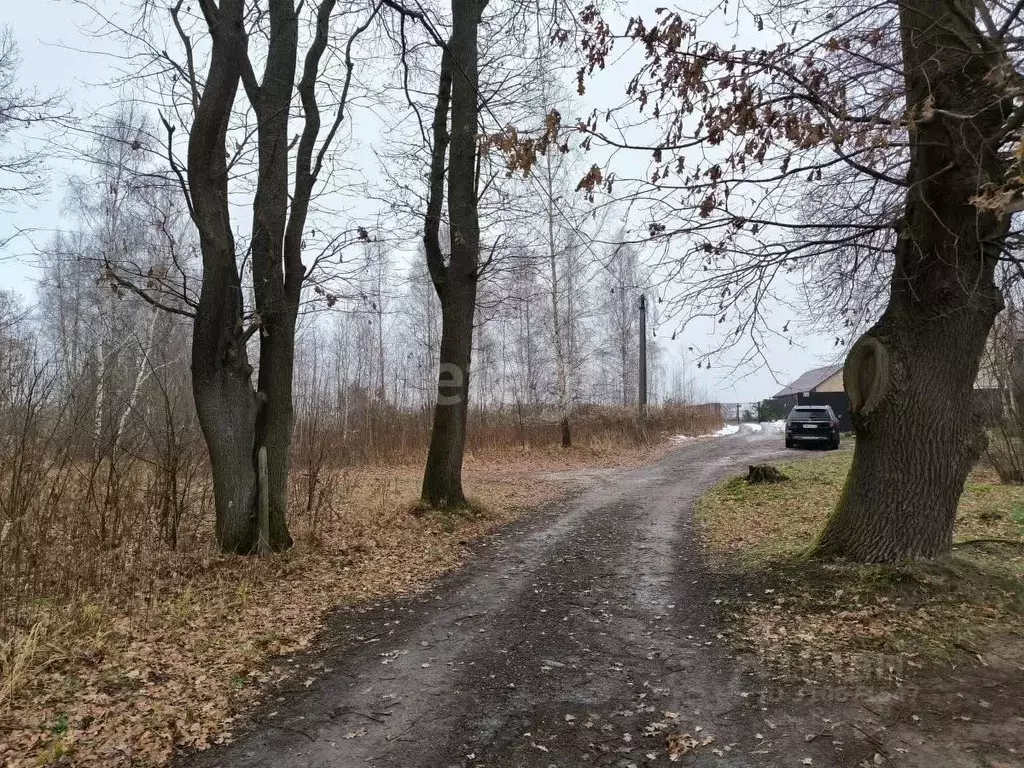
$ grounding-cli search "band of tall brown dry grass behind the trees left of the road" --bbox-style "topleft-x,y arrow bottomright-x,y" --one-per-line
0,406 -> 721,637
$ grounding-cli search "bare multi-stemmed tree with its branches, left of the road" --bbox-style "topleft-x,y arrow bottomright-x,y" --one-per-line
81,0 -> 381,554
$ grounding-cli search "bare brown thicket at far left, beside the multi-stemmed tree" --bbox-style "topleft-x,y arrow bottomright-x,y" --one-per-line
0,299 -> 210,628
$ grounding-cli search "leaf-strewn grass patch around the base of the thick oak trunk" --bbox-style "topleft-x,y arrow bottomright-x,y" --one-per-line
698,450 -> 1024,681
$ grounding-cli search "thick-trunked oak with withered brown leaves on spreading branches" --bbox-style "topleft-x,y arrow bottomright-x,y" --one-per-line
578,0 -> 1024,562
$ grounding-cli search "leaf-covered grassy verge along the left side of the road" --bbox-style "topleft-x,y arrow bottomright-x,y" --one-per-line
0,428 -> 704,768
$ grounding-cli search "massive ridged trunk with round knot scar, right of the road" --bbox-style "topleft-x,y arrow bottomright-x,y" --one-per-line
817,0 -> 1009,562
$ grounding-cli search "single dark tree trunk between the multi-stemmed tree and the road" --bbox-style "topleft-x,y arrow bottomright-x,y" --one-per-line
422,0 -> 486,507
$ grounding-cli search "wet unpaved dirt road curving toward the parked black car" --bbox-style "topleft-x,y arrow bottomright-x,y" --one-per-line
185,433 -> 870,768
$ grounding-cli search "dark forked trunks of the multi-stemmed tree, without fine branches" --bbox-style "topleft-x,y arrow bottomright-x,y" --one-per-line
188,0 -> 348,554
